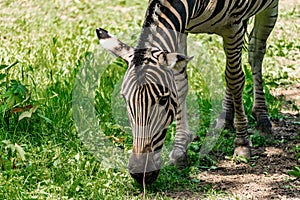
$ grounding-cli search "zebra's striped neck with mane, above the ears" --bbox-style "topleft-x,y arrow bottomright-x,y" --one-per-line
137,0 -> 197,52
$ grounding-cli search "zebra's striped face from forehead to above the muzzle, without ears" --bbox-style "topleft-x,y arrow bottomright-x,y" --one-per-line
121,50 -> 177,153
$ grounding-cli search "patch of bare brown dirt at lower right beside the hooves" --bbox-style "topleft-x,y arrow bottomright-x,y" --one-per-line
198,111 -> 300,199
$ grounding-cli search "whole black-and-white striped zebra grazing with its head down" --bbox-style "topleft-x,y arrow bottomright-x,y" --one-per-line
96,0 -> 278,184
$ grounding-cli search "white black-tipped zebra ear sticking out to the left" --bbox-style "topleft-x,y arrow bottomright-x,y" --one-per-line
96,28 -> 134,62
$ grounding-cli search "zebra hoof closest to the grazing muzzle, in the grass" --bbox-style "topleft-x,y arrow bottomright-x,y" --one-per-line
170,149 -> 189,170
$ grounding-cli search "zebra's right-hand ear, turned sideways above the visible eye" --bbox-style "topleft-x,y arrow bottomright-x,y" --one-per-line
159,53 -> 193,71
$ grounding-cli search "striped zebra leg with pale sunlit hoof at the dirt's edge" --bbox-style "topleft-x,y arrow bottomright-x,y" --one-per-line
223,26 -> 251,158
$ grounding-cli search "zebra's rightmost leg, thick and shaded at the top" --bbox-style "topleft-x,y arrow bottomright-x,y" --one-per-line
248,2 -> 278,136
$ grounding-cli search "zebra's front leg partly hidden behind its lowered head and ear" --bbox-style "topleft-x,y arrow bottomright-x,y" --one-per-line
170,34 -> 193,169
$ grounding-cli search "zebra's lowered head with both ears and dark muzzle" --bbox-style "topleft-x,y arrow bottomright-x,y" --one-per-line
96,28 -> 191,184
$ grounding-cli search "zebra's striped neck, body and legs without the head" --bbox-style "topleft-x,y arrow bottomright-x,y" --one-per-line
137,0 -> 278,162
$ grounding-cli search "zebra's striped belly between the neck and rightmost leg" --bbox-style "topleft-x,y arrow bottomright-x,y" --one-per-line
186,0 -> 278,36
